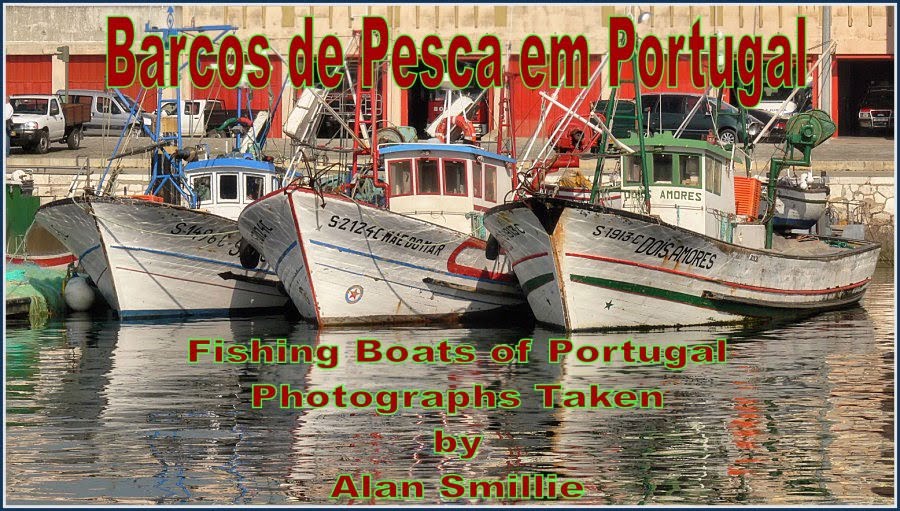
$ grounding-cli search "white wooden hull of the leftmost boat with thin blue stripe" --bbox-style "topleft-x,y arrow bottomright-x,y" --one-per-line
35,197 -> 288,318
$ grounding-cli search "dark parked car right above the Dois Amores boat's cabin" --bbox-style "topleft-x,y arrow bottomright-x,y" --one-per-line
641,92 -> 762,144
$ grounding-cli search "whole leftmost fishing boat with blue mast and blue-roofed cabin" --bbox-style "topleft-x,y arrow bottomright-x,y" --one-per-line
35,17 -> 288,318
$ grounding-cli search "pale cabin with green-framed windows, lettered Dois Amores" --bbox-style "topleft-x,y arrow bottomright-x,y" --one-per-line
621,133 -> 735,242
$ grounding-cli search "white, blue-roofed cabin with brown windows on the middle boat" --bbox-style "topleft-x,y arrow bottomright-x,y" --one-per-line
379,143 -> 516,232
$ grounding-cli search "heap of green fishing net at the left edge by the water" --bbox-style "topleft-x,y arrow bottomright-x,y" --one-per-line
5,263 -> 66,327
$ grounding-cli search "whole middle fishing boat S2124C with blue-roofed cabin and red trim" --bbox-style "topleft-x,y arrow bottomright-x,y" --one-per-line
238,143 -> 527,325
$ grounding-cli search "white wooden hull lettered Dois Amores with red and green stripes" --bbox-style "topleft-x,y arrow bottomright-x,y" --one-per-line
484,198 -> 879,330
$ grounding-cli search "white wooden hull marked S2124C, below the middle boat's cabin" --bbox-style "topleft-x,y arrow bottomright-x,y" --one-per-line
238,187 -> 527,325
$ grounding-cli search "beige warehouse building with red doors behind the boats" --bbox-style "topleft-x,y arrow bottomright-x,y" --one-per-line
5,4 -> 896,137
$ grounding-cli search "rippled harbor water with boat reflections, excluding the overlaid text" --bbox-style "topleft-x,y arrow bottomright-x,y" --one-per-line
5,268 -> 895,505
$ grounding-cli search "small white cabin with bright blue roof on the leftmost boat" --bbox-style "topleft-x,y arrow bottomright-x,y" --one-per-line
184,156 -> 281,220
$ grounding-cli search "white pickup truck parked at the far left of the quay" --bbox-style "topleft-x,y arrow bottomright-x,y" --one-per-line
9,94 -> 91,154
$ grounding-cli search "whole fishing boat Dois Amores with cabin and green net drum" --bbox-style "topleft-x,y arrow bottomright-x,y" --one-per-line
484,109 -> 880,330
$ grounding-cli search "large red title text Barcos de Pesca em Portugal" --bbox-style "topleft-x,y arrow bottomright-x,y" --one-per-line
106,16 -> 806,108
